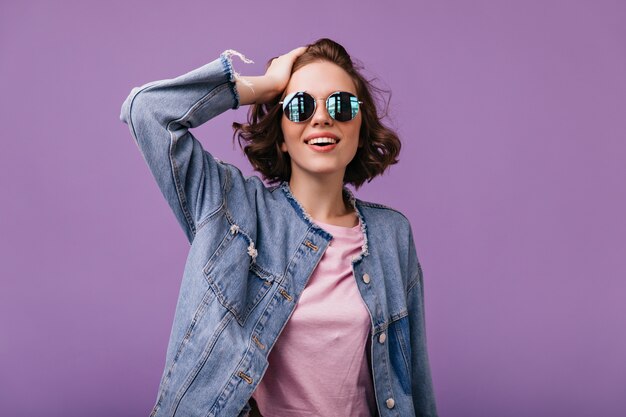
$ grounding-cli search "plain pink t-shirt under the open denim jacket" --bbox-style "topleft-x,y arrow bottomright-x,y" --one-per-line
252,216 -> 376,417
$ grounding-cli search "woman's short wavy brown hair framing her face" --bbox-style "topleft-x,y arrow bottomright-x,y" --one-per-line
232,38 -> 401,189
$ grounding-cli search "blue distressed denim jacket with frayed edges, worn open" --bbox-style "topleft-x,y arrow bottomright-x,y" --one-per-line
120,50 -> 437,417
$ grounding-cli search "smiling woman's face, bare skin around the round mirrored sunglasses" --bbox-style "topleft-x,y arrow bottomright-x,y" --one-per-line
281,61 -> 361,179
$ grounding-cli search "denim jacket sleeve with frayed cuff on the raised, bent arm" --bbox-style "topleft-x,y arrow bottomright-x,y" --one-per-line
120,50 -> 252,243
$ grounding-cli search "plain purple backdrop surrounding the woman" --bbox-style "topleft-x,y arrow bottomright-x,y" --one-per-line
0,0 -> 626,417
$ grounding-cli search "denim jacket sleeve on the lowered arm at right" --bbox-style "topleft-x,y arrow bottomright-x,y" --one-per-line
407,228 -> 438,417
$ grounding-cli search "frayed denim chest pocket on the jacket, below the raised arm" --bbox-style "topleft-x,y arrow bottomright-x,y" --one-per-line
203,229 -> 274,326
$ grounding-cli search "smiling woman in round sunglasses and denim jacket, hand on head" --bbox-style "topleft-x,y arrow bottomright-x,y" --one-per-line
120,39 -> 437,417
